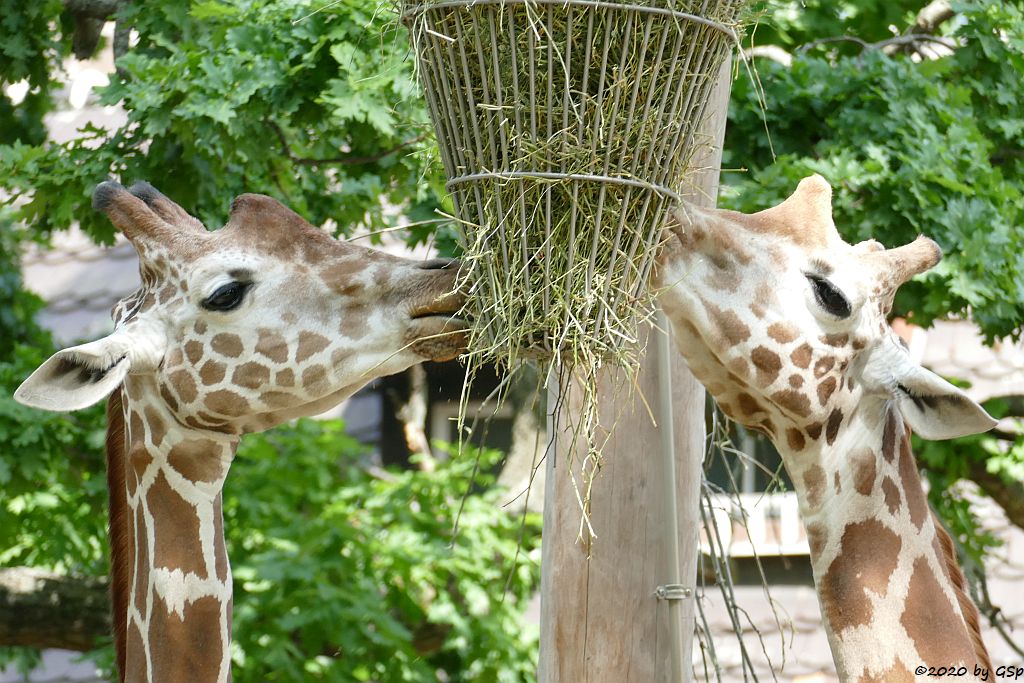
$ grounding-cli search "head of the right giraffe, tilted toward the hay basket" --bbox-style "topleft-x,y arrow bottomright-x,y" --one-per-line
655,175 -> 994,452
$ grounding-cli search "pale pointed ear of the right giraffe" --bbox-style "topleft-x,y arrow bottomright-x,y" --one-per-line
894,366 -> 995,440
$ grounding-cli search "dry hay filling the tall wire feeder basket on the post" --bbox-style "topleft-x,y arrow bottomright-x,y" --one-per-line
403,0 -> 745,540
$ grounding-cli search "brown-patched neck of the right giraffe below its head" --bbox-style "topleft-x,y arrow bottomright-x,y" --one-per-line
784,400 -> 991,681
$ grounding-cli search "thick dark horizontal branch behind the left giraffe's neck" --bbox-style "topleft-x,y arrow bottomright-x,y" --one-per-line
0,567 -> 111,652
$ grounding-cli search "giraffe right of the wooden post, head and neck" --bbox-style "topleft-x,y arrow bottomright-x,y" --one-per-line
655,176 -> 995,681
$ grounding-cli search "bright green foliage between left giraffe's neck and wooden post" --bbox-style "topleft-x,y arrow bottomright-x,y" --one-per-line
224,432 -> 540,683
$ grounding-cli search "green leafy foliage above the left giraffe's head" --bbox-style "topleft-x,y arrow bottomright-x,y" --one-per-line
0,0 -> 452,249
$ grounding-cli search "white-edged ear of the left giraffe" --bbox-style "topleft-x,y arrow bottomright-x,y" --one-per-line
14,335 -> 131,412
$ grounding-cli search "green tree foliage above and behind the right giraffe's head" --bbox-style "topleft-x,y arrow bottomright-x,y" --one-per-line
722,0 -> 1024,339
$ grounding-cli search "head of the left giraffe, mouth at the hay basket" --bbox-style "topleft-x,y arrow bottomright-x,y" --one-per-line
15,182 -> 466,433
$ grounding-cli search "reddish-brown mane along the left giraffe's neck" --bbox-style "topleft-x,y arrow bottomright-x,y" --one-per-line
106,387 -> 131,683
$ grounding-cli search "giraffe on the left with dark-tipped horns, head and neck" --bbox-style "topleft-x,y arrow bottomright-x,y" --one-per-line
15,181 -> 466,683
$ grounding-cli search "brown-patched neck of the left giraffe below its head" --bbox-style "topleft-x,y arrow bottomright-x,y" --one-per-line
109,376 -> 238,682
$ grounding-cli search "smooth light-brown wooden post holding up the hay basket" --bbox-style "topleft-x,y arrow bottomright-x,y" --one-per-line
538,60 -> 730,683
